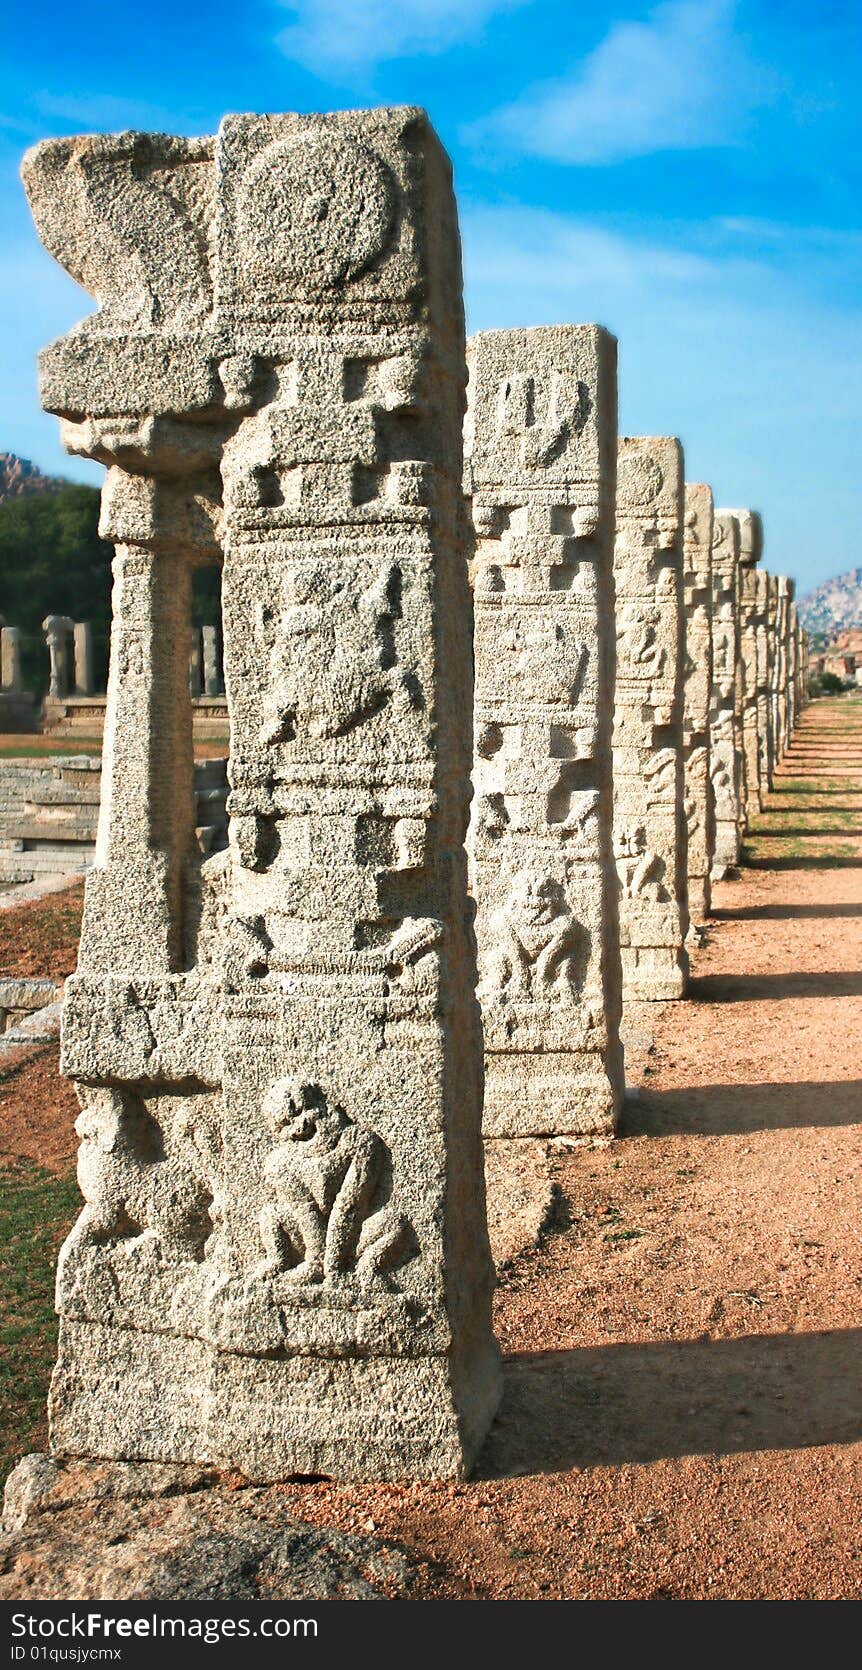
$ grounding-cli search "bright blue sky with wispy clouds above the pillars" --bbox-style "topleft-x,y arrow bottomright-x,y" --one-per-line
0,0 -> 862,590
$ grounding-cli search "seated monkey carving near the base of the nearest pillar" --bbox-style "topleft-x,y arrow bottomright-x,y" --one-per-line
257,1079 -> 409,1286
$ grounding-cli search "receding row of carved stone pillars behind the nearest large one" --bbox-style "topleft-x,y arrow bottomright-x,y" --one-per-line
466,335 -> 807,1137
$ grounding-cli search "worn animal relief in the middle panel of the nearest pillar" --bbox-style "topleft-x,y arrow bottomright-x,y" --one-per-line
262,563 -> 411,743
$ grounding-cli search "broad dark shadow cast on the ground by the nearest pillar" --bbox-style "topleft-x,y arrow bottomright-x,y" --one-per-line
479,1328 -> 862,1478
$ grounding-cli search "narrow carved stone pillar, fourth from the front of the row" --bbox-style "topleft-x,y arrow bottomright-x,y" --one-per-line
683,481 -> 715,925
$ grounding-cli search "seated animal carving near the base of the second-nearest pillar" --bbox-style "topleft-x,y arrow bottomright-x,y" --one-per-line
483,872 -> 583,1000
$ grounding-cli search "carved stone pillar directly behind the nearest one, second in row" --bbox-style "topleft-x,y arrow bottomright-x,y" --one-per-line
466,326 -> 623,1137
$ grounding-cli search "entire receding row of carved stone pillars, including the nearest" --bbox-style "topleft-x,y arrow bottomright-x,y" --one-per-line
25,109 -> 808,1478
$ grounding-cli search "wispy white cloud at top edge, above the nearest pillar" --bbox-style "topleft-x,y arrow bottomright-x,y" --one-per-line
277,0 -> 528,77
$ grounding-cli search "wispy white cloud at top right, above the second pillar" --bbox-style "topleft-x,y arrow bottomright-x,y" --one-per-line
473,0 -> 777,164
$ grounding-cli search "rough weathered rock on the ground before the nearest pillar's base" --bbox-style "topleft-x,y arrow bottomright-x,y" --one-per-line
0,1455 -> 423,1603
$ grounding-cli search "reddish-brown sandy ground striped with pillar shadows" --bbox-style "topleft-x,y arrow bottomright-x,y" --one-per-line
0,701 -> 862,1600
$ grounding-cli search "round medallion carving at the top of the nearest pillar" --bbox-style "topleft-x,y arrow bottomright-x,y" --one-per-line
239,135 -> 396,289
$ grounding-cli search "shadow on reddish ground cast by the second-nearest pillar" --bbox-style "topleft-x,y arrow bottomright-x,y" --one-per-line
620,1079 -> 862,1137
